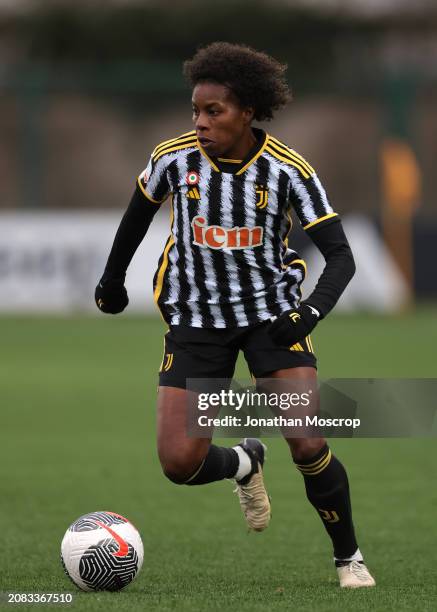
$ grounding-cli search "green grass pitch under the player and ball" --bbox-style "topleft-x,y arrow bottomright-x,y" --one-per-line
0,308 -> 437,612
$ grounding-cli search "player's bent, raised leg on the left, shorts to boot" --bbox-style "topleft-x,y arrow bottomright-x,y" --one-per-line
158,327 -> 270,530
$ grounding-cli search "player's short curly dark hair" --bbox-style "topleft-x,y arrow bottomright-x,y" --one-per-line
184,42 -> 291,121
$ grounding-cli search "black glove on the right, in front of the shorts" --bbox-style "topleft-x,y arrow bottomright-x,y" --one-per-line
267,302 -> 320,346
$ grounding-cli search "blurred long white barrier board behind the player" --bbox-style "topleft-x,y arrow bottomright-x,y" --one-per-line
0,211 -> 406,313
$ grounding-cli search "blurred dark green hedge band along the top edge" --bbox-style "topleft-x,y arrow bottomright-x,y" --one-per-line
0,0 -> 435,91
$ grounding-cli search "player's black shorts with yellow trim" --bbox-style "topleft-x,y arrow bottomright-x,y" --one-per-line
159,321 -> 317,389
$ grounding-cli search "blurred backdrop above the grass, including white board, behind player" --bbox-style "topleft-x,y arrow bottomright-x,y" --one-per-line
0,0 -> 437,312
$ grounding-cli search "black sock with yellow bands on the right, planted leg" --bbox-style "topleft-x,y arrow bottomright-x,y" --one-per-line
296,445 -> 358,559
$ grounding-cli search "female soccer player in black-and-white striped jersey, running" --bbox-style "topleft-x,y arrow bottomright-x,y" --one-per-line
95,42 -> 375,587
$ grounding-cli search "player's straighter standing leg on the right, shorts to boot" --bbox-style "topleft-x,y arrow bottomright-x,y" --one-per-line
244,323 -> 374,587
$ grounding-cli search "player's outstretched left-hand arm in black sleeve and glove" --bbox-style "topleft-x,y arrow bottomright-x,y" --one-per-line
95,158 -> 168,314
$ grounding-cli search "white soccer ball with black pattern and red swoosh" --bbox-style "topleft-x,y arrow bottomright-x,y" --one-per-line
61,512 -> 144,591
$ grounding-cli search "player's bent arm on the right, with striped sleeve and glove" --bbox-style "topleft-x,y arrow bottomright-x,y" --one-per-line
269,174 -> 355,346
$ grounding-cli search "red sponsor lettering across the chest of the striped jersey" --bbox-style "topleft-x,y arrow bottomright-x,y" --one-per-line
191,216 -> 263,249
